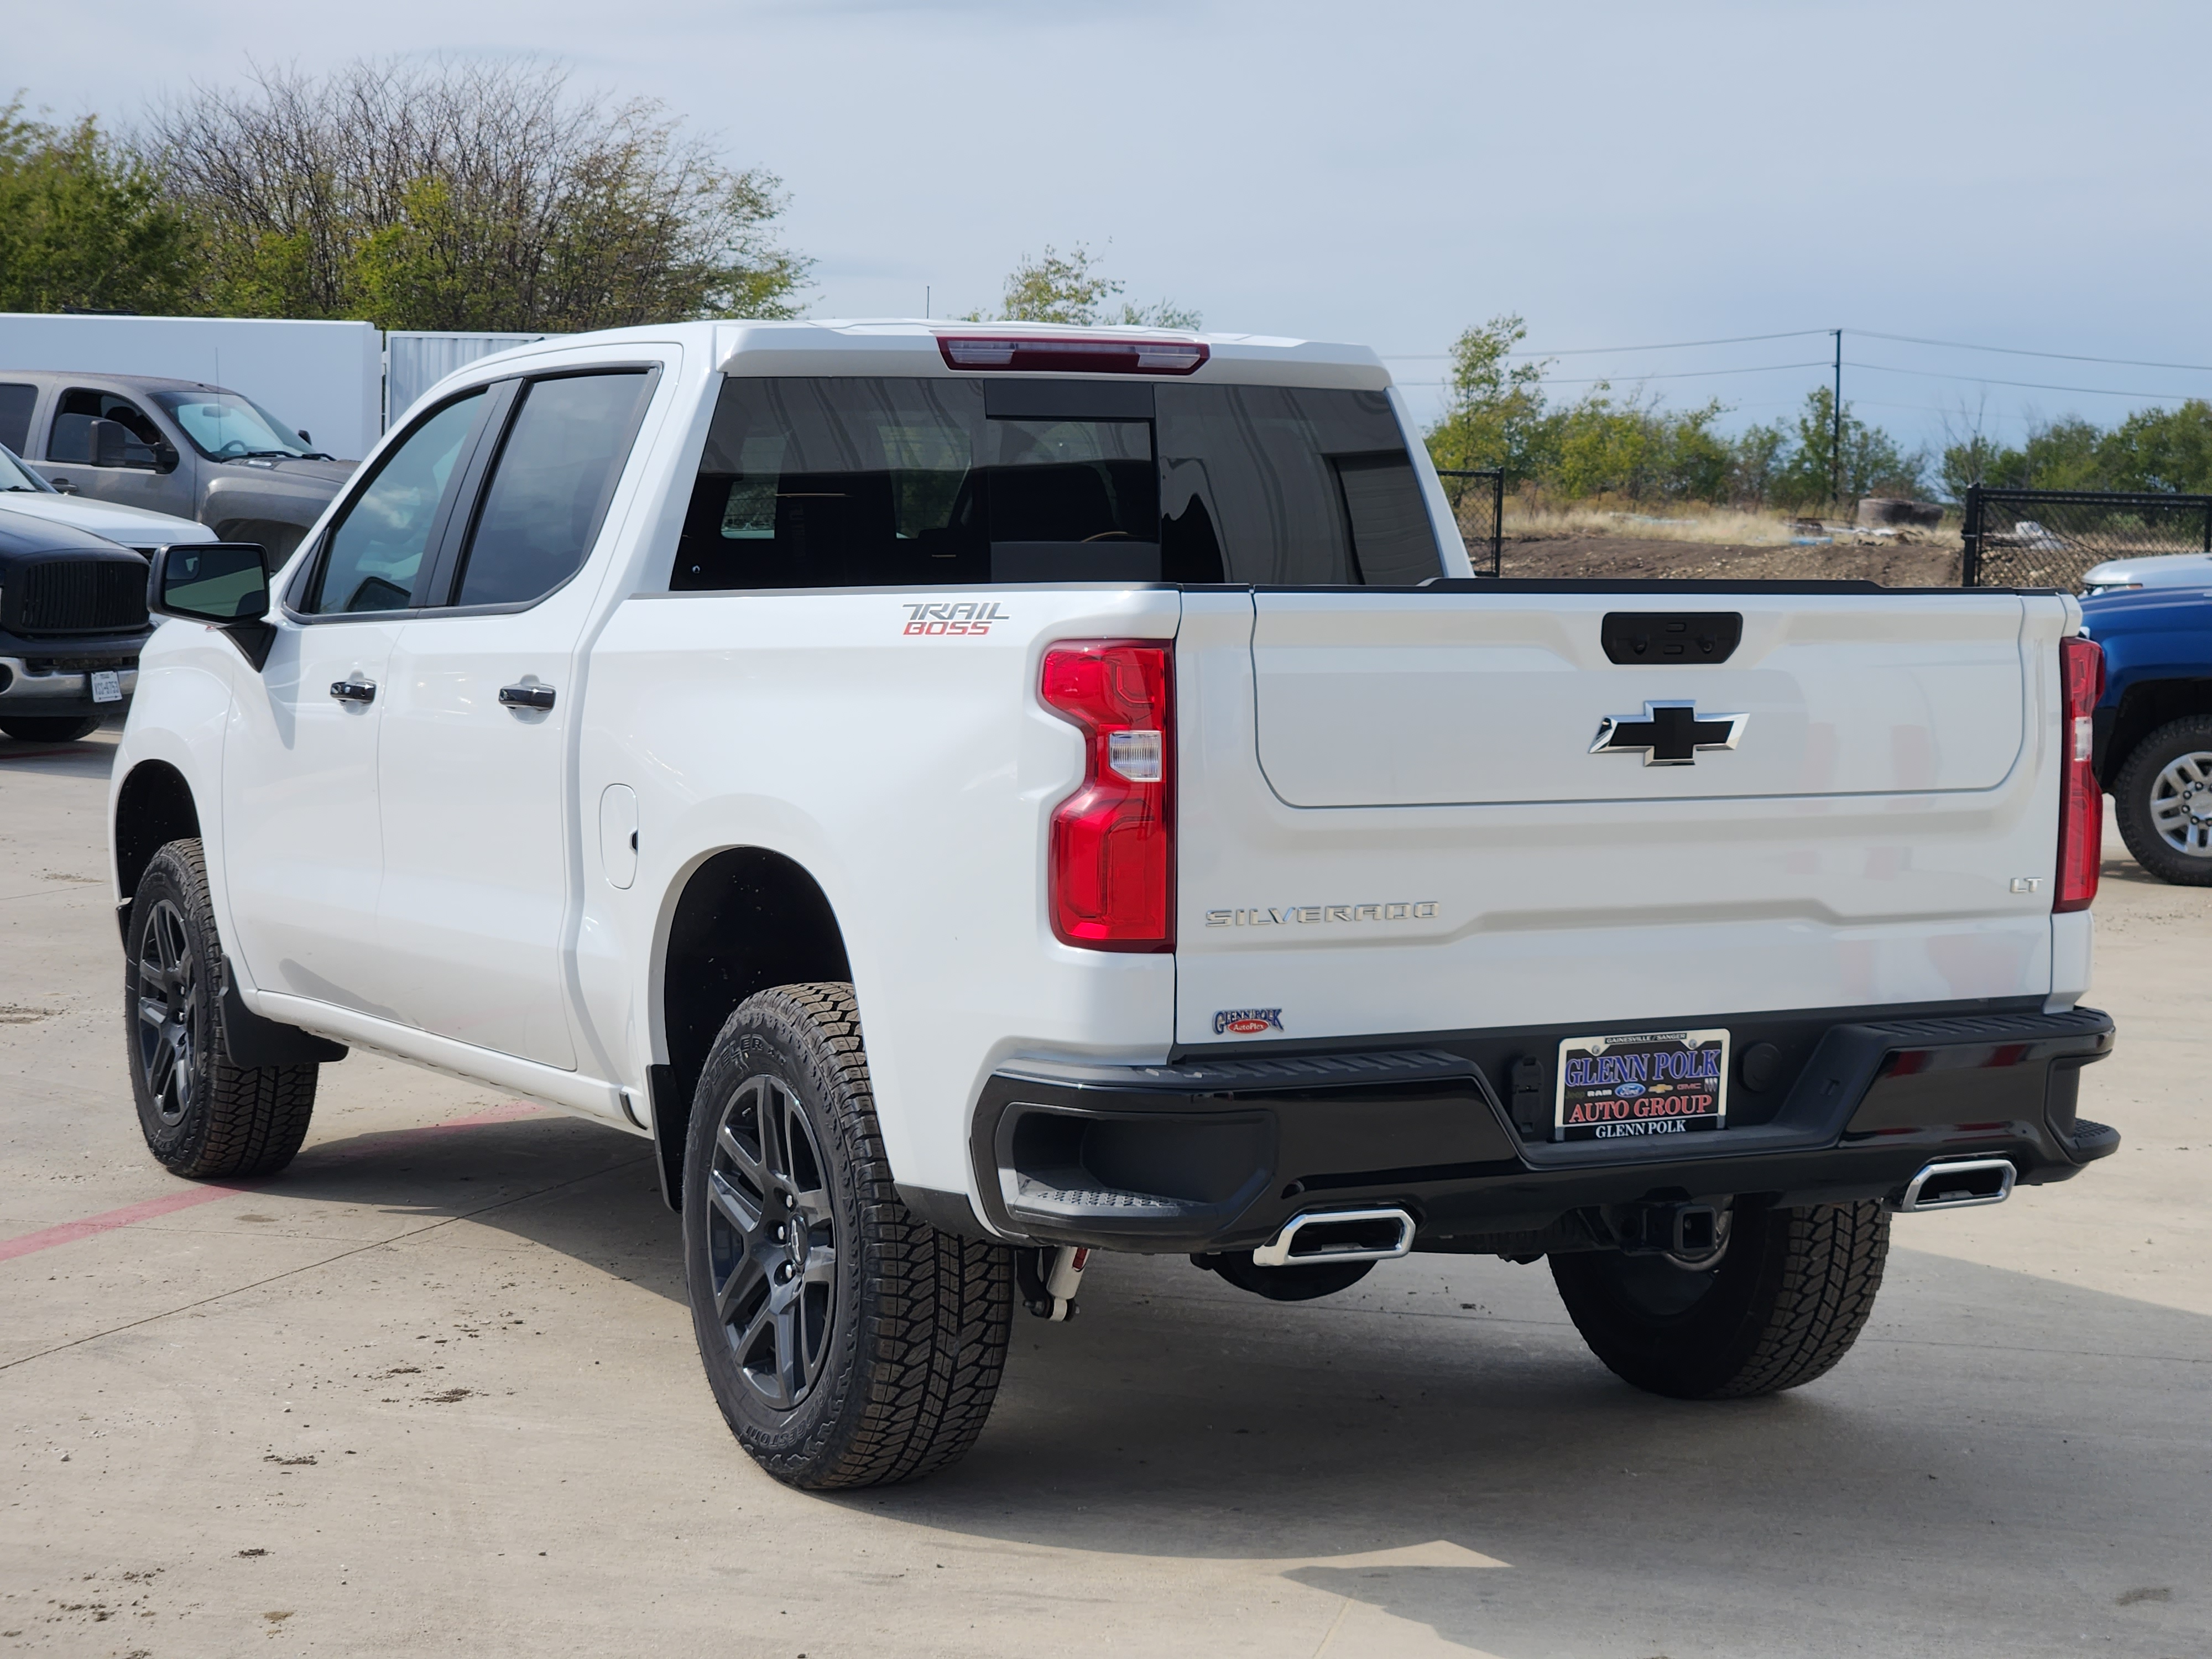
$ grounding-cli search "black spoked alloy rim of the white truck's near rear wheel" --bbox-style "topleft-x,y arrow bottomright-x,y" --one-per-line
706,1077 -> 838,1411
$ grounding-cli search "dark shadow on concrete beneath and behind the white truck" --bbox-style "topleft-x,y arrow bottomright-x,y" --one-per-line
268,1115 -> 2212,1659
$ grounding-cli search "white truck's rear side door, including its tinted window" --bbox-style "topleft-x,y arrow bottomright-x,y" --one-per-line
378,365 -> 655,1068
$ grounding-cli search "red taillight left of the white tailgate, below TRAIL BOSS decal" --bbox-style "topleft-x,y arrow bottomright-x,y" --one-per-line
1042,639 -> 1175,951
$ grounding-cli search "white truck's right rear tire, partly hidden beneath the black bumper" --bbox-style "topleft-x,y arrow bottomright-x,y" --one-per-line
1551,1199 -> 1889,1400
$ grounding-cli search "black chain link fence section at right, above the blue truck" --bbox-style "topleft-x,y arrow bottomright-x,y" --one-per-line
1962,484 -> 2212,591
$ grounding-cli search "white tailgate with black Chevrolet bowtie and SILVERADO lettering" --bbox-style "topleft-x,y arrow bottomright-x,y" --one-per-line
1177,588 -> 2066,1044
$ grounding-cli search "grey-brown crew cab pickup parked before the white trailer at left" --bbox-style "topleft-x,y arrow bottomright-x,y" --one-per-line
0,369 -> 356,560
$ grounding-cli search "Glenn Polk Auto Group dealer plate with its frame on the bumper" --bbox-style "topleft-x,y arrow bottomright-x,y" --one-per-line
1551,1026 -> 1730,1141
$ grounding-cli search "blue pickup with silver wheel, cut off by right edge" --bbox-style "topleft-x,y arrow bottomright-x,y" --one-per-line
2081,588 -> 2212,887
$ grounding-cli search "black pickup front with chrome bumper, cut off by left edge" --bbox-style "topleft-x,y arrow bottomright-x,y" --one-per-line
0,515 -> 153,743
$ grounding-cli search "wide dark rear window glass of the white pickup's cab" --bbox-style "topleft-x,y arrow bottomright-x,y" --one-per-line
670,378 -> 1442,588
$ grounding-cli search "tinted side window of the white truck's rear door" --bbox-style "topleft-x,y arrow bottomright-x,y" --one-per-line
453,369 -> 648,604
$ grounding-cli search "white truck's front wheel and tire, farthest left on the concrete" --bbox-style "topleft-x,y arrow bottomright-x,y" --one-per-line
124,841 -> 316,1181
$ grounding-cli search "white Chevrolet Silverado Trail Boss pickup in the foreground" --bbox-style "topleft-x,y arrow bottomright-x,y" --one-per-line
113,323 -> 2119,1486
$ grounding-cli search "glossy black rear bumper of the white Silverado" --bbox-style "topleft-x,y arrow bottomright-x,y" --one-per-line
960,1004 -> 2119,1254
